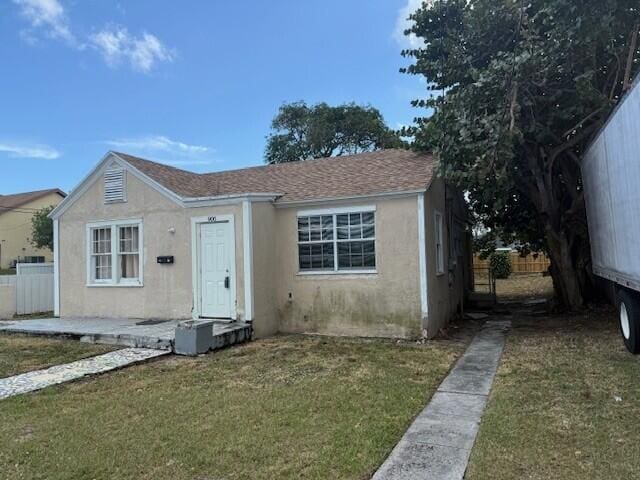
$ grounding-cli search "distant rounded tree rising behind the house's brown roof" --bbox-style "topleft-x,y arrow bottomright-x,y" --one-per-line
265,102 -> 404,163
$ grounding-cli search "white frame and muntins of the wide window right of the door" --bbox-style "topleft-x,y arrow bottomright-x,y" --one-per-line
295,205 -> 378,275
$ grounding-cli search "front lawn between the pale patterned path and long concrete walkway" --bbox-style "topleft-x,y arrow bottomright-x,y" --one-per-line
0,336 -> 464,480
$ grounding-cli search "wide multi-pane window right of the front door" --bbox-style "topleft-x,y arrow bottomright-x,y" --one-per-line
298,209 -> 376,272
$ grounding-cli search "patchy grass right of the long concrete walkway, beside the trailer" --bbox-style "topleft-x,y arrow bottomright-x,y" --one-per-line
465,309 -> 640,480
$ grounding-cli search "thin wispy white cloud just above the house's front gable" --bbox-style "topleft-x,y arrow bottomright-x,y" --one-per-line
106,135 -> 213,166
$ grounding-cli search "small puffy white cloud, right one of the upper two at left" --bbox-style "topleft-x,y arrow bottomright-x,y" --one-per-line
89,26 -> 175,72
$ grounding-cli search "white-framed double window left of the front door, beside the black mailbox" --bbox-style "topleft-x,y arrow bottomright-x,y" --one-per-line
87,220 -> 142,286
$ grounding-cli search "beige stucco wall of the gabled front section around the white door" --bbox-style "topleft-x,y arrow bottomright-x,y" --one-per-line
59,174 -> 244,319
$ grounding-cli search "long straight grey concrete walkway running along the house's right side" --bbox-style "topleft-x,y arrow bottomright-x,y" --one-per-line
373,321 -> 511,480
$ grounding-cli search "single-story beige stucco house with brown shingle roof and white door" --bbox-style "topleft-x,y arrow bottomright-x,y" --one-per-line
51,150 -> 471,338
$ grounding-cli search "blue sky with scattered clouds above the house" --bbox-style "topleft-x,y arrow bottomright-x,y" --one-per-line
0,0 -> 427,194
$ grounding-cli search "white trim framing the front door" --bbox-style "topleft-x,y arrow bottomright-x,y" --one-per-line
191,214 -> 238,320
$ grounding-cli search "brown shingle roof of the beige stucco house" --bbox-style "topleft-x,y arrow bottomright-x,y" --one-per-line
114,150 -> 436,201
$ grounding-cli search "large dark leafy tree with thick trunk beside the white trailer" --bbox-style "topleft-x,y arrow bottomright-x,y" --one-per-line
403,0 -> 640,309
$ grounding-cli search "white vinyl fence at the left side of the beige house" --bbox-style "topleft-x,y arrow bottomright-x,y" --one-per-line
0,263 -> 54,315
